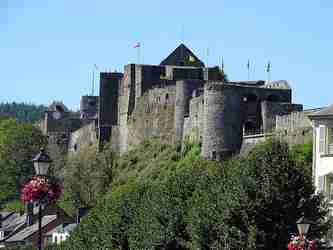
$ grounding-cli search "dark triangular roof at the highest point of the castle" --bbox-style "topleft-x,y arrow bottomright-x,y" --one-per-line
160,43 -> 205,67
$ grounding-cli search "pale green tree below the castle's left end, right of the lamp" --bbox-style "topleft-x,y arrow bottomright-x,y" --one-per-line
62,145 -> 117,212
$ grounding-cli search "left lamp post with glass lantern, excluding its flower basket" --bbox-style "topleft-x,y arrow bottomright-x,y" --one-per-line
32,148 -> 52,250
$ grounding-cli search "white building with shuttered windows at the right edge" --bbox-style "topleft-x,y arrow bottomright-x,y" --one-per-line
309,105 -> 333,201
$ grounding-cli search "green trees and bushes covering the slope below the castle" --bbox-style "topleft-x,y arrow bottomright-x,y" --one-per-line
5,141 -> 330,250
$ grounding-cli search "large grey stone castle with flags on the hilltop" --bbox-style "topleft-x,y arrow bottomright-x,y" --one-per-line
43,44 -> 303,160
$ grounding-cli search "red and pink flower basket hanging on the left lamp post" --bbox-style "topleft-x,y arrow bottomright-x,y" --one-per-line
21,176 -> 62,203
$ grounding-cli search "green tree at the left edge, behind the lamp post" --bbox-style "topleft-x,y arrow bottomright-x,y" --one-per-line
0,119 -> 46,202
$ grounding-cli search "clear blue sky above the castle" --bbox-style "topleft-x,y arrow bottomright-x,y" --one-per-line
0,0 -> 333,108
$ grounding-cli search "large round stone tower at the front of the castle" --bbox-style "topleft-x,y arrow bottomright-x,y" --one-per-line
201,83 -> 242,160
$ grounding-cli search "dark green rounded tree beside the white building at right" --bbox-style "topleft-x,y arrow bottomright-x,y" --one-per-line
242,140 -> 331,249
